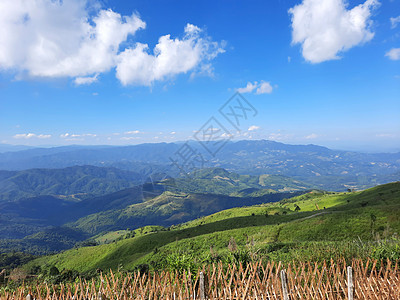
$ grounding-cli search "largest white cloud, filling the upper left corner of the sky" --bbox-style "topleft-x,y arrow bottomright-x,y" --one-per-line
0,0 -> 146,77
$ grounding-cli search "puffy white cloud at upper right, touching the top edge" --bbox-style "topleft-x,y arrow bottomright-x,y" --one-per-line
289,0 -> 379,63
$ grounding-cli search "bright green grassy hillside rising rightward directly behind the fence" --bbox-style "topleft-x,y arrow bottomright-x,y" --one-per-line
26,182 -> 400,271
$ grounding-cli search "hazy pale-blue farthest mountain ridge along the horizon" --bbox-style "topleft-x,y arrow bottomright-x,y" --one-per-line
0,140 -> 400,191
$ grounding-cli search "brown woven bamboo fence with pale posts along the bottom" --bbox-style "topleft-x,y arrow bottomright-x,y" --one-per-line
0,259 -> 400,300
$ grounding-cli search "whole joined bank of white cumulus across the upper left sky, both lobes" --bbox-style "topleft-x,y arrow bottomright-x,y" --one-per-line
0,0 -> 223,85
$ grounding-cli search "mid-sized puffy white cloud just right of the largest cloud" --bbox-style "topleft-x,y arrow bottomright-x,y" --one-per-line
116,24 -> 224,86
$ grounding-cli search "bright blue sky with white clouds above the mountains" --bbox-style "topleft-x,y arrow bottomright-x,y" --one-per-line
0,0 -> 400,151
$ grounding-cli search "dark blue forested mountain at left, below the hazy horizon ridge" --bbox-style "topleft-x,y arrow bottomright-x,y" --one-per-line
0,166 -> 144,202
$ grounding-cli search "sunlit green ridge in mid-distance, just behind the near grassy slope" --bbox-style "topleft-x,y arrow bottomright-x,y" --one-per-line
67,191 -> 304,234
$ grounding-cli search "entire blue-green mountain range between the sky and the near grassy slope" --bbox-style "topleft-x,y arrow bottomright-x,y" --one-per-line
0,140 -> 400,254
